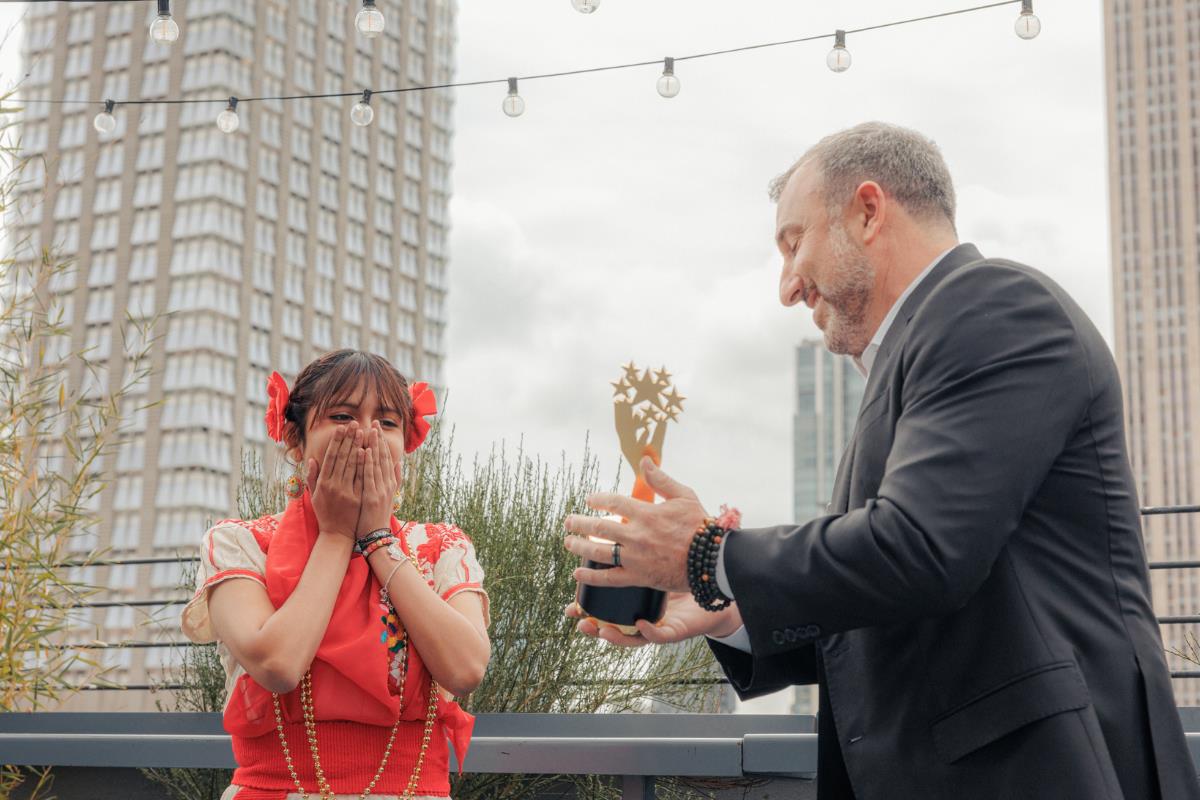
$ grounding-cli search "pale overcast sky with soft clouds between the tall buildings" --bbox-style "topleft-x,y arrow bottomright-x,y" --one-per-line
0,0 -> 1111,710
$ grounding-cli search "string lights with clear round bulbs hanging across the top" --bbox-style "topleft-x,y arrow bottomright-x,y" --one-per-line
23,0 -> 1042,136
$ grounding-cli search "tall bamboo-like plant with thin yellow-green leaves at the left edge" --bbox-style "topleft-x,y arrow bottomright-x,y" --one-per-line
0,94 -> 155,798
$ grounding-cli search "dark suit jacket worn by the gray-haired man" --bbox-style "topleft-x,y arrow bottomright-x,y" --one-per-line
713,245 -> 1200,800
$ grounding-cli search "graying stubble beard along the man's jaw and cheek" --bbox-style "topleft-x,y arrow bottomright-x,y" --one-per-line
821,224 -> 875,356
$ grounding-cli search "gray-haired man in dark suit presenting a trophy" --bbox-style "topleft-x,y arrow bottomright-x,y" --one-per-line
565,122 -> 1200,800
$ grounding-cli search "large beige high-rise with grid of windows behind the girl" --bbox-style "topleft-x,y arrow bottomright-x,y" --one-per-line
14,0 -> 456,708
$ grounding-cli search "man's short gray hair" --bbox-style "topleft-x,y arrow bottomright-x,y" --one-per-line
767,122 -> 954,227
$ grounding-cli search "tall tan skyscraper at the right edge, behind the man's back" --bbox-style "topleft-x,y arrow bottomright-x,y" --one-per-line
1104,0 -> 1200,705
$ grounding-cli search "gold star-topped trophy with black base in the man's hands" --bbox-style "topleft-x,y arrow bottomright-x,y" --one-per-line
575,362 -> 686,636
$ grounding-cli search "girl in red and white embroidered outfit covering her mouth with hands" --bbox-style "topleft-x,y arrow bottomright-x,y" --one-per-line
182,350 -> 491,800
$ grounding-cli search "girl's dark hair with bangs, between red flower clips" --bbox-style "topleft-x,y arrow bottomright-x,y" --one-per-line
283,349 -> 414,450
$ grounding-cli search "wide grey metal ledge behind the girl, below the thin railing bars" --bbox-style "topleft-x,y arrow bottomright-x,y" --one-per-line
0,712 -> 817,800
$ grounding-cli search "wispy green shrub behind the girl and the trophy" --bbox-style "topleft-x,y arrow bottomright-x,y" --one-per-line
148,425 -> 716,800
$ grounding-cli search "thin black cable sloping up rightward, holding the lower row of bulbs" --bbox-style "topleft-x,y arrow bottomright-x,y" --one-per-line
21,0 -> 1021,106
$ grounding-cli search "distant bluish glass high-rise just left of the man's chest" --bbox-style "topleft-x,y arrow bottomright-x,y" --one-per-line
791,339 -> 866,714
